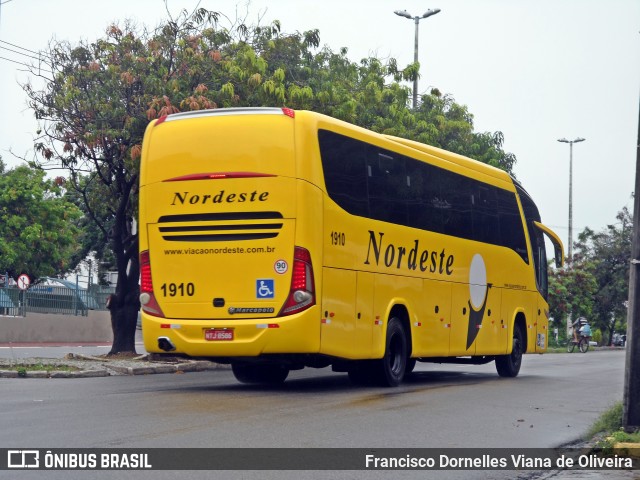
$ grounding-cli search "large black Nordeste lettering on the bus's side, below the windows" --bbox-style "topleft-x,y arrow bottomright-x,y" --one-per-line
364,230 -> 454,275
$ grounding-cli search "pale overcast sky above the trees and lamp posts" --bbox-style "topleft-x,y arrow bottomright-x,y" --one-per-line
0,0 -> 640,248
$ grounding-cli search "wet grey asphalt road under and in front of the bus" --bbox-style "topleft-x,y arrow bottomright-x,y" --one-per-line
0,350 -> 625,479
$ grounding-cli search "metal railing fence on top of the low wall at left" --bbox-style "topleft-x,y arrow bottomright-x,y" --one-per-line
0,284 -> 115,316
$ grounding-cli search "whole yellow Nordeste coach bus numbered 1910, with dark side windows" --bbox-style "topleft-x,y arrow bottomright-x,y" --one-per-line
139,108 -> 563,386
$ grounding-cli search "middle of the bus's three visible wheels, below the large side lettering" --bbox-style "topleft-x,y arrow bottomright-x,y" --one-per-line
374,317 -> 408,387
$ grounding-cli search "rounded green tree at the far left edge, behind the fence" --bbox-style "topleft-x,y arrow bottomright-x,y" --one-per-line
0,158 -> 80,281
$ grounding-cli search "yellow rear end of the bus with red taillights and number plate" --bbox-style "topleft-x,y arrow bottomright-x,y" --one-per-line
140,108 -> 322,370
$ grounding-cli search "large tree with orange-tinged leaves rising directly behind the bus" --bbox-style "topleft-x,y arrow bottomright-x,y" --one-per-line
24,9 -> 515,353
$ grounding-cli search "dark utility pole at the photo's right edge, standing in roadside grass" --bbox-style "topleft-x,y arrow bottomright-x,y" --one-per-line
622,94 -> 640,432
